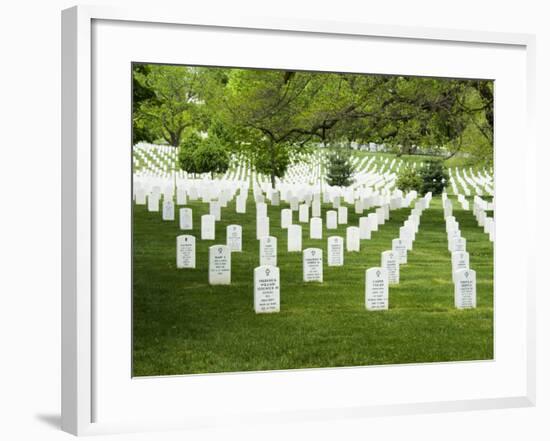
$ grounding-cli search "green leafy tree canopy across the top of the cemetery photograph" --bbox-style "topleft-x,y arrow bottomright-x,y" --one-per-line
133,64 -> 493,185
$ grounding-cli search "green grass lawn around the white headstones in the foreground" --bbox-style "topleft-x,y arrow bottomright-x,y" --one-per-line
133,195 -> 493,376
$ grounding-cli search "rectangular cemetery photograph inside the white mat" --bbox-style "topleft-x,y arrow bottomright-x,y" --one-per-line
133,61 -> 495,377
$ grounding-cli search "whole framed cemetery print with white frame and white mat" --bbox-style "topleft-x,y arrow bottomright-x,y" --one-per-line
62,6 -> 536,434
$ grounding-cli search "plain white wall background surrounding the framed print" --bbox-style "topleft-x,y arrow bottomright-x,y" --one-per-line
0,0 -> 550,441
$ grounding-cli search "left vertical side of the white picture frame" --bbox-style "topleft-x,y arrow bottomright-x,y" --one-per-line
61,7 -> 92,435
